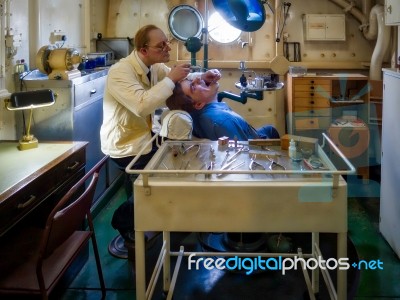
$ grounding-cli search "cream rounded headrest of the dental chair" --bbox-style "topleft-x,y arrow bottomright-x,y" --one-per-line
160,110 -> 193,140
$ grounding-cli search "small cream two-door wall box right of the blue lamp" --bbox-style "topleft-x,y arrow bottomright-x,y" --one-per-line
304,14 -> 346,41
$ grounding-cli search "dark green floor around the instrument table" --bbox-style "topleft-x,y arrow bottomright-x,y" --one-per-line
57,175 -> 400,300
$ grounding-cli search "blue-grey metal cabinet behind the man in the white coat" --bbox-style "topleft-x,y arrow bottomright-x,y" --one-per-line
17,70 -> 121,206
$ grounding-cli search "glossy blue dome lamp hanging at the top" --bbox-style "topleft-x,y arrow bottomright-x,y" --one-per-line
213,0 -> 266,32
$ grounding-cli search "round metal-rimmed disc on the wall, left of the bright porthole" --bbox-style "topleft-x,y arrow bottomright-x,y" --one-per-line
168,5 -> 204,42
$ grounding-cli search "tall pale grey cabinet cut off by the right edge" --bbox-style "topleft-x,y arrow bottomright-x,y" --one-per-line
379,69 -> 400,257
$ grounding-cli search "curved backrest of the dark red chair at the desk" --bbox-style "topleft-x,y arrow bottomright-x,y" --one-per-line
40,156 -> 108,258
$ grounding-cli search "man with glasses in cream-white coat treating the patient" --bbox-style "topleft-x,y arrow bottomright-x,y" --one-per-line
100,25 -> 221,246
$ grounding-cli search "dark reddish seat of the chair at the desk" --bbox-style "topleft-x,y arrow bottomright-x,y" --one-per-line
0,228 -> 90,294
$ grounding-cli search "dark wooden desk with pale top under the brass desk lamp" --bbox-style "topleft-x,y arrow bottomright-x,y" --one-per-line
0,142 -> 87,236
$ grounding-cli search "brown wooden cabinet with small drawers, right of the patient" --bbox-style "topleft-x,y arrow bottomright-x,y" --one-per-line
286,74 -> 369,177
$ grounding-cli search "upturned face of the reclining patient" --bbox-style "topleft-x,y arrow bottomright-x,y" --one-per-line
181,78 -> 219,103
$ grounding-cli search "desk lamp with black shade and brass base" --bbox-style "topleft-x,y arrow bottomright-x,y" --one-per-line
6,89 -> 55,150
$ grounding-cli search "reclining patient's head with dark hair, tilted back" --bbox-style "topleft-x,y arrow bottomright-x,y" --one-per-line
167,78 -> 219,112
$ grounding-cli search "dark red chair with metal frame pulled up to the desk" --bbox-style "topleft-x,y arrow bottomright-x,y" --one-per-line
0,156 -> 108,299
